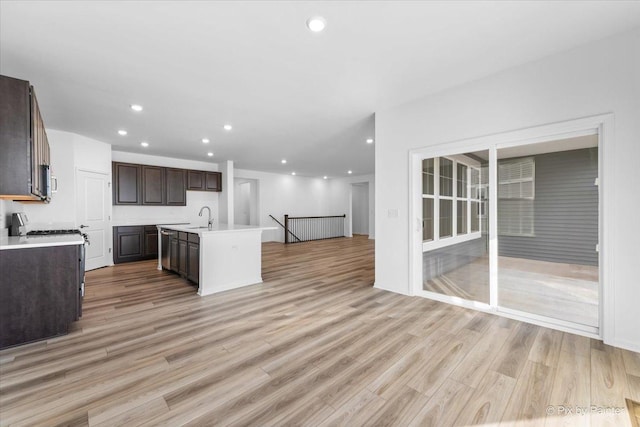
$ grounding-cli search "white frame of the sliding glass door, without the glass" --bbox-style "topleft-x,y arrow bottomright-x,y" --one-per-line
408,113 -> 615,343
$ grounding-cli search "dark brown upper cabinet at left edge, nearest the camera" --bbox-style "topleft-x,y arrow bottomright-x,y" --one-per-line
0,76 -> 51,202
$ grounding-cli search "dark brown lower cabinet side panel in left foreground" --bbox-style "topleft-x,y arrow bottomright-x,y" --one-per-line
0,245 -> 82,349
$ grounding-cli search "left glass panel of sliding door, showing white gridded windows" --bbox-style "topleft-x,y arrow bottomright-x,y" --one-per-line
422,150 -> 489,304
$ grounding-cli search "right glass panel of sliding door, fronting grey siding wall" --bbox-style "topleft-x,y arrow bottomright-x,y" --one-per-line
497,135 -> 599,327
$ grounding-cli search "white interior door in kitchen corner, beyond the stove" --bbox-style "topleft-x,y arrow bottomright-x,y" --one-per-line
76,170 -> 111,270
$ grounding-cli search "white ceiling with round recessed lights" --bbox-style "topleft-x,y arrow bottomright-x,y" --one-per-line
0,0 -> 640,177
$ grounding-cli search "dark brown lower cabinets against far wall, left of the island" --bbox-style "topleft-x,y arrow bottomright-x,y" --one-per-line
113,225 -> 158,264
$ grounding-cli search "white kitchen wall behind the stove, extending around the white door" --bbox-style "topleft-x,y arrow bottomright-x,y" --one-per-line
2,129 -> 111,228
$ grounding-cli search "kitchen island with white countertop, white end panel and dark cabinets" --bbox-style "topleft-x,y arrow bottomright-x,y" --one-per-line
157,224 -> 275,296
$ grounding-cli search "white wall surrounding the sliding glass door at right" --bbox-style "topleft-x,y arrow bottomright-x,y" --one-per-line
375,30 -> 640,351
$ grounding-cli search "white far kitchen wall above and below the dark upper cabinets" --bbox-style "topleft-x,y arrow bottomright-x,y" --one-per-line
109,151 -> 220,225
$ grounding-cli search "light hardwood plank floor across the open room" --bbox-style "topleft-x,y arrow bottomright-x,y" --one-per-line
0,237 -> 640,426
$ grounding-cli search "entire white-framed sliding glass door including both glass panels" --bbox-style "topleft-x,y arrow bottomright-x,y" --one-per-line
410,116 -> 611,338
